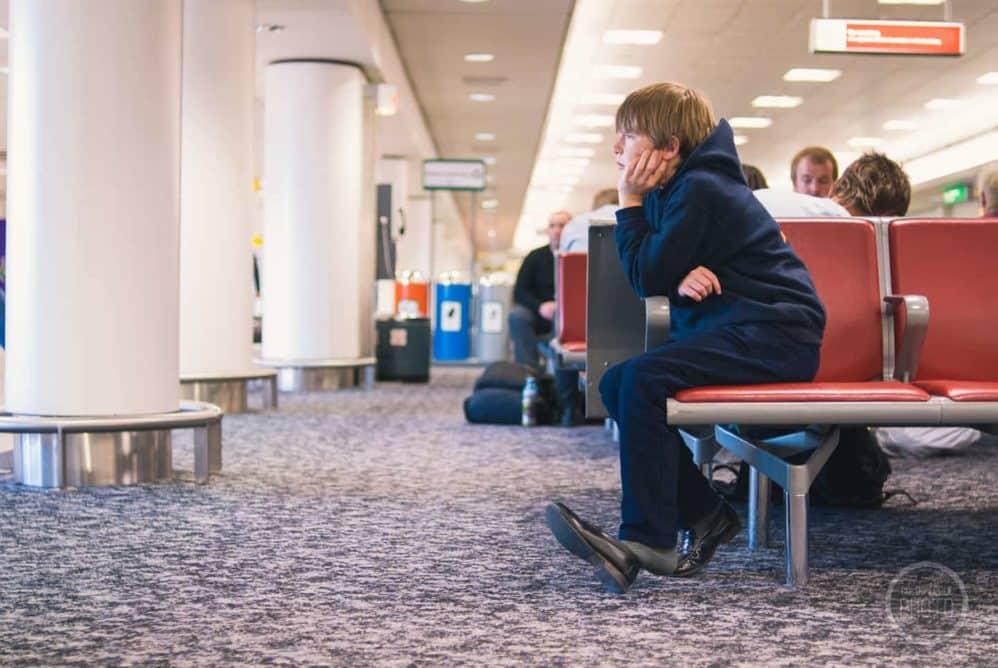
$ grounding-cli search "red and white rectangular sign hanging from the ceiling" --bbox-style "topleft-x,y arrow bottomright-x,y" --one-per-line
809,19 -> 966,56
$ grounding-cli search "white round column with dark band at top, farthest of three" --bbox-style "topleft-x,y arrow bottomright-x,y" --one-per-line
261,61 -> 375,362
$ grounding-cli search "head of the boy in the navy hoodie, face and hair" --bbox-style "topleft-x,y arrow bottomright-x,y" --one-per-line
613,83 -> 717,188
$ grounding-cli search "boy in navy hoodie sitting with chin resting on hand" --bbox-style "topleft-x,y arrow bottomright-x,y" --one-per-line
546,83 -> 825,593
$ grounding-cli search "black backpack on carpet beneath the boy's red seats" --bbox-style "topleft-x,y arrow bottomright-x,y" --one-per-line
713,427 -> 911,508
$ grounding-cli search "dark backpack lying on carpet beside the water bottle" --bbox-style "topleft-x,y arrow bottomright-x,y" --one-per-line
464,362 -> 558,424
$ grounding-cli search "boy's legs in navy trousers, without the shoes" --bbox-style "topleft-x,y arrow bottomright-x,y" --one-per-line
600,326 -> 818,547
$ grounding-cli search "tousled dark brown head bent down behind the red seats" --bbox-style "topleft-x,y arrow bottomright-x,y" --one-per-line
829,153 -> 911,216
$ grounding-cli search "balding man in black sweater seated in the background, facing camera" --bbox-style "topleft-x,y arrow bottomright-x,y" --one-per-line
509,211 -> 572,373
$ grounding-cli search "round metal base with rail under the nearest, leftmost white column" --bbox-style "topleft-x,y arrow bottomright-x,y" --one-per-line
0,402 -> 222,488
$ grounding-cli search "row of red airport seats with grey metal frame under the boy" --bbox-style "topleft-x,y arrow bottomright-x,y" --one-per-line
552,218 -> 998,586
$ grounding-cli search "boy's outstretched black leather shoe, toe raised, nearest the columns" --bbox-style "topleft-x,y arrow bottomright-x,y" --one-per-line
544,503 -> 641,594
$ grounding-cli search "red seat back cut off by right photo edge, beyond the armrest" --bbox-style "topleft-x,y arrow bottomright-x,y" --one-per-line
888,218 -> 998,381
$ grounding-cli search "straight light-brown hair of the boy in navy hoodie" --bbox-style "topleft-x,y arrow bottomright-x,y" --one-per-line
617,82 -> 717,159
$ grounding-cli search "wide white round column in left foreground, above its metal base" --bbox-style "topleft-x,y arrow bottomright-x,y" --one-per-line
6,0 -> 182,416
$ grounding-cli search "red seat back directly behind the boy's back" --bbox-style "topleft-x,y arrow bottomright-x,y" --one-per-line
777,218 -> 884,382
